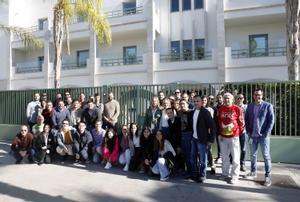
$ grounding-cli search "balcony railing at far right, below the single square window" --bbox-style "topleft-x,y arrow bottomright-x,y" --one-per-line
231,47 -> 286,59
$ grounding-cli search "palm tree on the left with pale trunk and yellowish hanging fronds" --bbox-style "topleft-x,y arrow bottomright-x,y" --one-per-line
53,0 -> 111,88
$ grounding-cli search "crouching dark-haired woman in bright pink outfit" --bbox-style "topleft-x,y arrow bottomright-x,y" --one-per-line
102,128 -> 119,170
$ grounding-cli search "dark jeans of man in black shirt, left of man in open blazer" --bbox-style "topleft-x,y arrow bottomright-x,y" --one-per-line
181,132 -> 193,176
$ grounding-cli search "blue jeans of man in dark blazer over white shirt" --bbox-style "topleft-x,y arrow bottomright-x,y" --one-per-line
191,137 -> 208,177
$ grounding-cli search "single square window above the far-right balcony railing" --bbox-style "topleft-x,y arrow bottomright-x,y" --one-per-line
249,34 -> 268,57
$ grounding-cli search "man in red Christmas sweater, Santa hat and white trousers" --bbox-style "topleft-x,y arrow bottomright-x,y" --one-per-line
218,93 -> 245,184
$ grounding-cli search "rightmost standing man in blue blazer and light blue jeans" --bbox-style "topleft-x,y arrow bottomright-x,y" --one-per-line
245,89 -> 275,186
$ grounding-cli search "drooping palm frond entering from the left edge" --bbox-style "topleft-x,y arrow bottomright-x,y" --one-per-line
0,24 -> 43,48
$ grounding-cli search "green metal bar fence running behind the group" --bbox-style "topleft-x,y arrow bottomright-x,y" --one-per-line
0,82 -> 300,137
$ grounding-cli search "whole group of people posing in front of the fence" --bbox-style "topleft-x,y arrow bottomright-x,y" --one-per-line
11,89 -> 274,186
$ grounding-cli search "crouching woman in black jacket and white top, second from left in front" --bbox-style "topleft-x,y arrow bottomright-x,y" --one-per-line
35,124 -> 55,165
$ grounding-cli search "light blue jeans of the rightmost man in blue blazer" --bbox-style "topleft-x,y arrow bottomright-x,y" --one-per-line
250,137 -> 272,177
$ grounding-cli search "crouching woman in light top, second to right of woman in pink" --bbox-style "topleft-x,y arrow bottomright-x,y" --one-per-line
129,123 -> 142,171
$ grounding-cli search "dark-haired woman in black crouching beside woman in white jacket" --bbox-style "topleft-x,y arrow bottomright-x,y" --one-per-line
140,127 -> 154,173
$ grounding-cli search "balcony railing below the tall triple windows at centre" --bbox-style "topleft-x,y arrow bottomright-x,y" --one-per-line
160,51 -> 212,62
